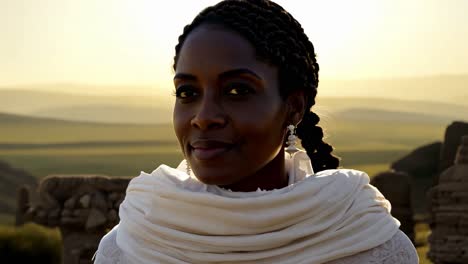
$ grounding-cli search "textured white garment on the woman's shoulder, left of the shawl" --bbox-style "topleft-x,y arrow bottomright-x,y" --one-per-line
94,225 -> 122,264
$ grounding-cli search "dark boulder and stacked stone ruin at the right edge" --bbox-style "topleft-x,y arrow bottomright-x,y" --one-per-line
371,122 -> 468,256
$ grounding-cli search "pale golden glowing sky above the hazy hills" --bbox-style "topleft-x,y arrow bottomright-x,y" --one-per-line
0,0 -> 468,93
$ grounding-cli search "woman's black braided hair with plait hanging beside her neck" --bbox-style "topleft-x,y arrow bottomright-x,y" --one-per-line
173,0 -> 339,172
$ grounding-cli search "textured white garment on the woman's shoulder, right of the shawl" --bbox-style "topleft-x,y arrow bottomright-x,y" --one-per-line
329,230 -> 419,264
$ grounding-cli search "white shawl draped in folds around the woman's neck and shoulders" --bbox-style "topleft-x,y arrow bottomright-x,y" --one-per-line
116,156 -> 399,264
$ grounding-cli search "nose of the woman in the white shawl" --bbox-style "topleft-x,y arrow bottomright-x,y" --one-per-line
190,96 -> 227,130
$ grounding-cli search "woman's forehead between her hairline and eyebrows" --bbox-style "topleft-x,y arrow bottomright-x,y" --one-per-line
176,25 -> 274,77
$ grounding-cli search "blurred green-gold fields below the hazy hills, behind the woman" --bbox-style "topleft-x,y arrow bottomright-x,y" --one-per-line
0,117 -> 445,178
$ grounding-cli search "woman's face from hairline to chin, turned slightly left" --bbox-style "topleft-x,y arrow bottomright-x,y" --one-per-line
173,25 -> 288,189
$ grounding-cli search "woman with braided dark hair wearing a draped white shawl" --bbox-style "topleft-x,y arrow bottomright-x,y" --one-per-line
96,0 -> 418,264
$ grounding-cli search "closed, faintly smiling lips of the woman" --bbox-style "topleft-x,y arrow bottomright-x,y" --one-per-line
190,139 -> 234,160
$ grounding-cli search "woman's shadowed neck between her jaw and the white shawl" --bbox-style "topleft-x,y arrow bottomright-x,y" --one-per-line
220,151 -> 288,192
